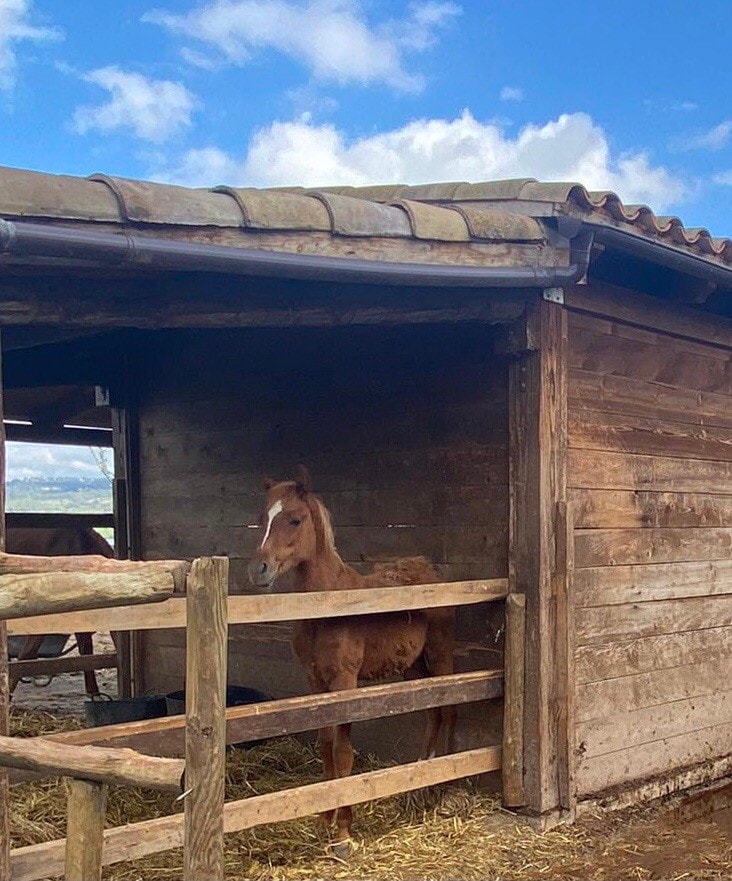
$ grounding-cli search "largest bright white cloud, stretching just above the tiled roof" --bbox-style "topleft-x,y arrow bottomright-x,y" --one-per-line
153,110 -> 686,210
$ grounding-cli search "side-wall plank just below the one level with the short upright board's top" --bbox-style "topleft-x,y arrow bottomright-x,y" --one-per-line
575,527 -> 732,569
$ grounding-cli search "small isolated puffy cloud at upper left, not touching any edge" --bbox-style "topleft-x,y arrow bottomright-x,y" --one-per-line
73,67 -> 197,143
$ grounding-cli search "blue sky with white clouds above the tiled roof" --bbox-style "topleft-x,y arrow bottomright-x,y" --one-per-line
0,0 -> 732,235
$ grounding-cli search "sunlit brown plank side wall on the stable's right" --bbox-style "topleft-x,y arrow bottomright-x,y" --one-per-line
568,313 -> 732,796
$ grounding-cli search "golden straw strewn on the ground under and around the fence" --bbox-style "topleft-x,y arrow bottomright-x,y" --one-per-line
11,711 -> 732,881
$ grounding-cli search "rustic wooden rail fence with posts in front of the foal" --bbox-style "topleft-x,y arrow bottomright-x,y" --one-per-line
0,554 -> 508,881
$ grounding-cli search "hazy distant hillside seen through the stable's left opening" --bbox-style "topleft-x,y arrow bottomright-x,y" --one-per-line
6,476 -> 112,514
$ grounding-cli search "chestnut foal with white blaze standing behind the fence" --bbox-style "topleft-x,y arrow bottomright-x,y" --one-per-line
249,470 -> 456,856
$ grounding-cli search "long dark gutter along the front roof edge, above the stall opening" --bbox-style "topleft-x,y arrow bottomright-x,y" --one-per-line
0,219 -> 593,288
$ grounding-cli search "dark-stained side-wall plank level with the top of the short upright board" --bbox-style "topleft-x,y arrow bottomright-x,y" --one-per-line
569,488 -> 732,529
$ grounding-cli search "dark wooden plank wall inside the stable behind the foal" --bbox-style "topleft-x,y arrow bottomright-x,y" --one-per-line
133,325 -> 508,758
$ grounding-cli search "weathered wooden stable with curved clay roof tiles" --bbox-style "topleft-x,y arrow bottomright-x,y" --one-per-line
0,163 -> 732,846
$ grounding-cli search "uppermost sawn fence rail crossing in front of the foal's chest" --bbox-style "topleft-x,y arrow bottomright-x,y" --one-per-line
8,578 -> 508,635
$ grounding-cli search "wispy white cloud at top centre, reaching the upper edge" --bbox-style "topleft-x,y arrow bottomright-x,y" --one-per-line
143,0 -> 460,91
